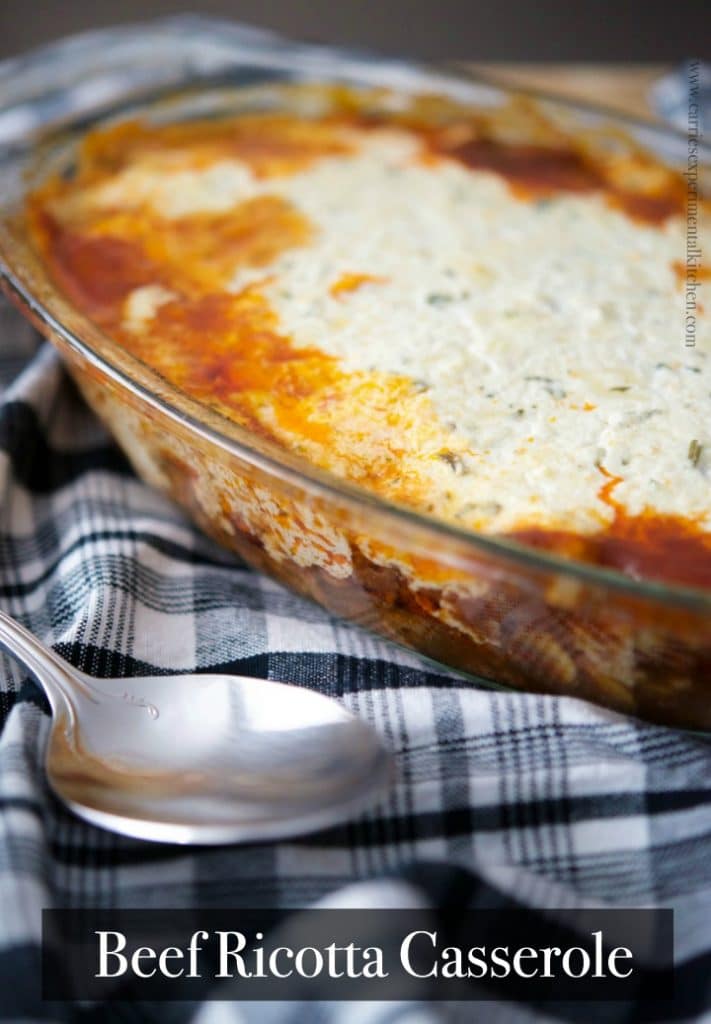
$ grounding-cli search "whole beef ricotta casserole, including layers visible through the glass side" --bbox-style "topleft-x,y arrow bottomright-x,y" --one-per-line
5,86 -> 711,726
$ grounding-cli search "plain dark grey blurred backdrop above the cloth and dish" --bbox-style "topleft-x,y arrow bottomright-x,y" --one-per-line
0,0 -> 711,61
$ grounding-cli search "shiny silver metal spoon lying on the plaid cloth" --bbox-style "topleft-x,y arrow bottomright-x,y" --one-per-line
0,611 -> 392,843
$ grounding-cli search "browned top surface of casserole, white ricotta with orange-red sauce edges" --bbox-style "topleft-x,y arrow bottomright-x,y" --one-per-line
29,103 -> 711,584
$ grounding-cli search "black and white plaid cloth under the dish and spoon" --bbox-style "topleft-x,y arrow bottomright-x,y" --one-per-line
0,19 -> 711,1024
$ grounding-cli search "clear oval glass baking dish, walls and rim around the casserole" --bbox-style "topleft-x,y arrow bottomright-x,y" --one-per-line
0,66 -> 711,730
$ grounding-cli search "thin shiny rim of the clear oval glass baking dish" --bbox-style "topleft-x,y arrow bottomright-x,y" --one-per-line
0,72 -> 711,613
